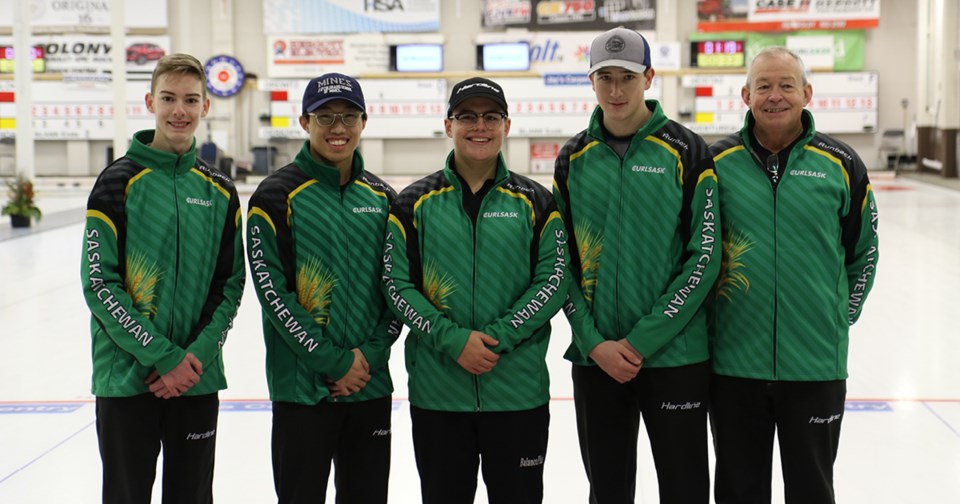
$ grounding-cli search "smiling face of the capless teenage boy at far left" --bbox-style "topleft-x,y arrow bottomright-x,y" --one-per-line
145,72 -> 210,154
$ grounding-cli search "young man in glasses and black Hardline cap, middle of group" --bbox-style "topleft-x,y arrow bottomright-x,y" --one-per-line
384,78 -> 567,504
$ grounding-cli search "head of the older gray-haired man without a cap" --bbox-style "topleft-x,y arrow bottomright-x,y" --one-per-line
741,52 -> 813,137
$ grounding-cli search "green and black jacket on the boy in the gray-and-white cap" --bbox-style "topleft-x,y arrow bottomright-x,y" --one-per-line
554,100 -> 720,367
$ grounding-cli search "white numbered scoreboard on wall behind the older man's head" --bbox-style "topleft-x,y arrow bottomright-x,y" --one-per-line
682,72 -> 878,135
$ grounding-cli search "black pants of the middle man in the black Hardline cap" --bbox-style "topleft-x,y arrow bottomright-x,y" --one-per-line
410,404 -> 550,504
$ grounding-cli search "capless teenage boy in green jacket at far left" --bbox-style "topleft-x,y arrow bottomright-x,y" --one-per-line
81,54 -> 244,503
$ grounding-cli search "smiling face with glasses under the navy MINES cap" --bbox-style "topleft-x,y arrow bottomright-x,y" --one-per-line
300,100 -> 367,173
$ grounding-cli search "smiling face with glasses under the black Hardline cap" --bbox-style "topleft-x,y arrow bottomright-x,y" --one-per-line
443,98 -> 510,166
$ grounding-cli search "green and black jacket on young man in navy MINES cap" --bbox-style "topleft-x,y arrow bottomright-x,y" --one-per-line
247,141 -> 402,404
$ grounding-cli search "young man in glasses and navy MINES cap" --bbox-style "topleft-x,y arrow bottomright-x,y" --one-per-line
247,73 -> 402,503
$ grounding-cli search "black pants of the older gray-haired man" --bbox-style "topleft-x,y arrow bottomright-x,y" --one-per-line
710,375 -> 847,504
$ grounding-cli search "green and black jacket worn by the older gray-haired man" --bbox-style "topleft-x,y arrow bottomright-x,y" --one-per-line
710,110 -> 879,381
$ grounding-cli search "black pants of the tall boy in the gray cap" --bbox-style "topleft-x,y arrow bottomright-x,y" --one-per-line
573,362 -> 710,504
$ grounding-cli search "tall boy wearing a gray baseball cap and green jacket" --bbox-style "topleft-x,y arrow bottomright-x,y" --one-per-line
553,27 -> 721,504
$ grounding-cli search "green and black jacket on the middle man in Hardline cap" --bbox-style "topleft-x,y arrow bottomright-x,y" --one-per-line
384,153 -> 567,412
